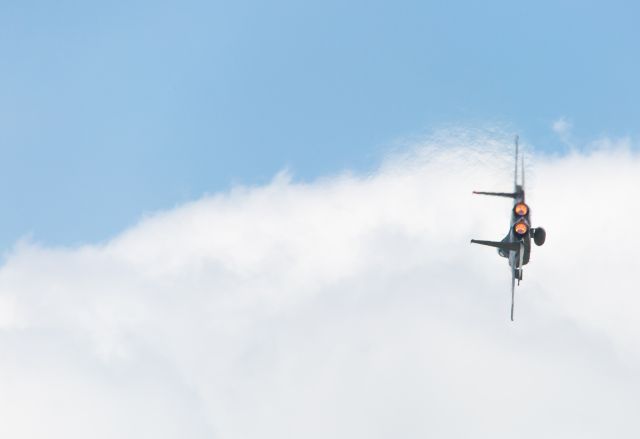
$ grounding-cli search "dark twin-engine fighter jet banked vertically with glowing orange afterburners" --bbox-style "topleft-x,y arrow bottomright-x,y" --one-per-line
471,136 -> 547,321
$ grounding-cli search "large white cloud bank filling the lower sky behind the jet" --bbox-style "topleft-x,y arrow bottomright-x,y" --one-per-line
0,134 -> 640,439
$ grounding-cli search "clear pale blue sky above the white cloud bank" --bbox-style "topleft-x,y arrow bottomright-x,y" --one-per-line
0,1 -> 640,249
